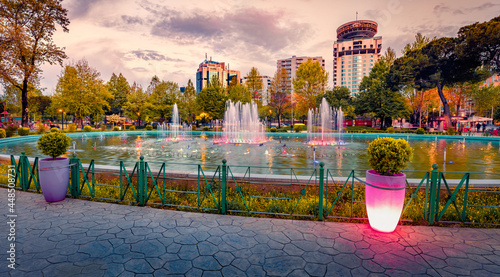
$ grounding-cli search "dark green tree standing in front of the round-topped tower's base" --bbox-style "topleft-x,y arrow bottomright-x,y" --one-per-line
354,58 -> 407,128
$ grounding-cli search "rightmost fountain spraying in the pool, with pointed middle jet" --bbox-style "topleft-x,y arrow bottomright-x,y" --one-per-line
306,98 -> 345,145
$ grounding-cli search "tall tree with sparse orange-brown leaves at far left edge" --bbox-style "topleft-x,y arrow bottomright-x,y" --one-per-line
0,0 -> 69,127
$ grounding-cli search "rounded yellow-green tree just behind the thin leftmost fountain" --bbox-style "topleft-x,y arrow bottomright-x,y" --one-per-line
148,81 -> 182,122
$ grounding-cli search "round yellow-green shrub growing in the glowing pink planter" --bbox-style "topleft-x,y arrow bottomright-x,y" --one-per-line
368,138 -> 413,175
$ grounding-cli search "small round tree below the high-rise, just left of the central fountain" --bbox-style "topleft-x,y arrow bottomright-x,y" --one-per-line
196,86 -> 227,119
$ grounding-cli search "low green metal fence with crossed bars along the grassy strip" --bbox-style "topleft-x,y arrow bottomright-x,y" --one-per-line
2,153 -> 500,225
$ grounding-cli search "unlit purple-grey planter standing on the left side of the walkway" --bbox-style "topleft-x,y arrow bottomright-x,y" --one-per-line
38,158 -> 69,202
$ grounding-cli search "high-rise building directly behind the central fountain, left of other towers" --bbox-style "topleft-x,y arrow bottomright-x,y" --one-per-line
196,56 -> 241,93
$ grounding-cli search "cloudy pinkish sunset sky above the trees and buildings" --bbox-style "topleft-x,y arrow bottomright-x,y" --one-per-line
40,0 -> 500,95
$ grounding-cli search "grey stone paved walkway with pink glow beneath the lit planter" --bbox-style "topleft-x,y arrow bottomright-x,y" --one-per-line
0,189 -> 500,276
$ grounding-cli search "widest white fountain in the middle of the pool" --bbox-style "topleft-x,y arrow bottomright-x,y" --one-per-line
214,101 -> 266,144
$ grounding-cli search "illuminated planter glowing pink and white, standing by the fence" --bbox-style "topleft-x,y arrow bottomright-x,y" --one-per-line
365,170 -> 406,233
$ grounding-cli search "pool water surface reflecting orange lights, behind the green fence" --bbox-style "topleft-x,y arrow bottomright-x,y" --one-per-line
0,132 -> 500,179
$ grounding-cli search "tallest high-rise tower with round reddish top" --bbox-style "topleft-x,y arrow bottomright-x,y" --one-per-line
333,20 -> 382,96
